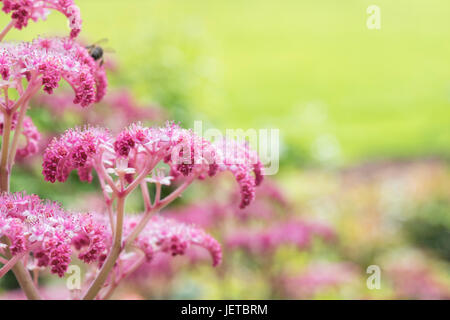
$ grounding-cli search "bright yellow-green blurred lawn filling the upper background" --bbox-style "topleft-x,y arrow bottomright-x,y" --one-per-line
1,0 -> 450,162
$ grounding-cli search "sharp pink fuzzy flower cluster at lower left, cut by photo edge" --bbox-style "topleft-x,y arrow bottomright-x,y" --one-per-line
0,193 -> 107,277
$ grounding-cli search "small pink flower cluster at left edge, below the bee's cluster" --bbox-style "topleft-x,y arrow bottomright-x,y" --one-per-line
0,112 -> 41,159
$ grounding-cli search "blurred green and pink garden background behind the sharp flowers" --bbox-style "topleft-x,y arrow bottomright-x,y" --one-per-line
0,0 -> 450,299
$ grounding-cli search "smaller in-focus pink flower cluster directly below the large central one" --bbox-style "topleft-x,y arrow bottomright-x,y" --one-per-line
124,215 -> 222,266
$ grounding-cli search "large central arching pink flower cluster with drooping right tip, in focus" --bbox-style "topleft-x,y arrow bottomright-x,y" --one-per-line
42,122 -> 263,208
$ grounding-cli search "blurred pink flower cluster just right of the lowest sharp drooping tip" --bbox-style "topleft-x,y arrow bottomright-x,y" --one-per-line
225,221 -> 335,254
